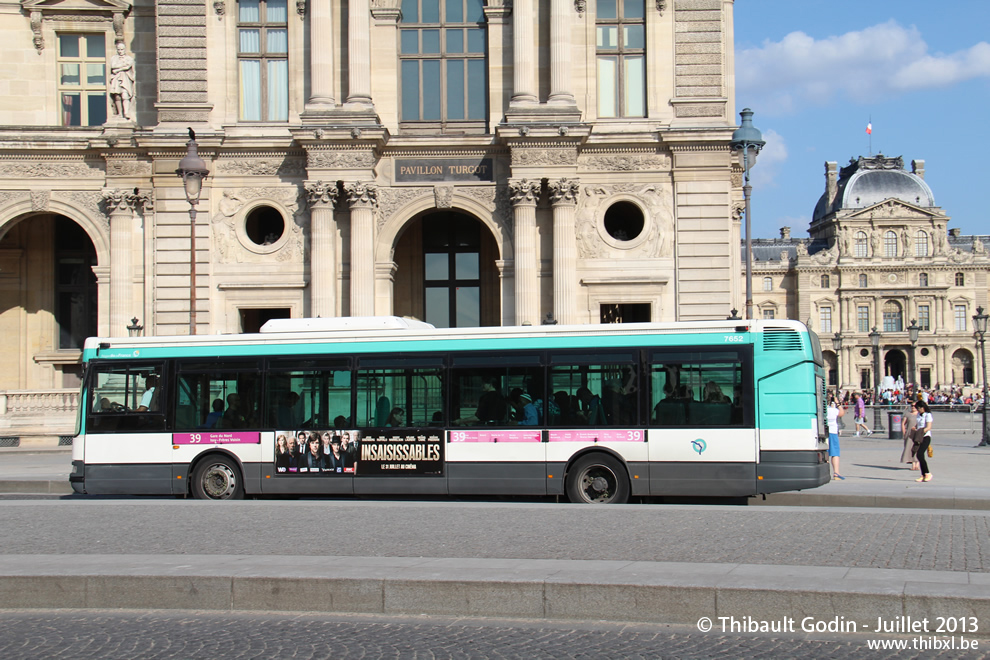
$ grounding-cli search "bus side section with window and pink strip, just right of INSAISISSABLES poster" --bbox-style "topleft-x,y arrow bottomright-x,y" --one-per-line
446,353 -> 547,495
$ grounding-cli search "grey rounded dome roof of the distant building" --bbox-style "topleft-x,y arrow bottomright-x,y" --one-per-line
814,154 -> 935,220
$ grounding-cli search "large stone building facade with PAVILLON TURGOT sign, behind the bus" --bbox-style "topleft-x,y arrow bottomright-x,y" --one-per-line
0,0 -> 741,438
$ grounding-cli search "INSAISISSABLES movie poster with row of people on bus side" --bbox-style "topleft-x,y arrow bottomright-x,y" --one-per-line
275,429 -> 443,477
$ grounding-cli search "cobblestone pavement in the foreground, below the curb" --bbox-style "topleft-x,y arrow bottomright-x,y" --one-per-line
0,610 -> 990,660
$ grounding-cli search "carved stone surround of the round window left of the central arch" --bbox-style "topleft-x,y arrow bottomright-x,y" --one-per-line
210,187 -> 308,263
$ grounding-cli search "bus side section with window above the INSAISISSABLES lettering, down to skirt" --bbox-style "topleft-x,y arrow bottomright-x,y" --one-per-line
350,355 -> 447,495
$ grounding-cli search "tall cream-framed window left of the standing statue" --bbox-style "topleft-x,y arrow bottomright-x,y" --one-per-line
58,33 -> 107,126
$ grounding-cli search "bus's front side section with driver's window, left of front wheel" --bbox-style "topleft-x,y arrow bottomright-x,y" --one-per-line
83,361 -> 172,495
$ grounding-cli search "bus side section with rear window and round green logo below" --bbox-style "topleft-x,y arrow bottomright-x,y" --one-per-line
649,345 -> 758,496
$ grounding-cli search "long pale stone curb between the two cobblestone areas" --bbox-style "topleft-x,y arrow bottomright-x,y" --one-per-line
0,555 -> 990,632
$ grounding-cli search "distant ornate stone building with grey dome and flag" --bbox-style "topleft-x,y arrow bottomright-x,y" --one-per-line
753,155 -> 990,390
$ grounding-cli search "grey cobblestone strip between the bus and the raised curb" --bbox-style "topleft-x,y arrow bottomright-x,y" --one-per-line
0,500 -> 990,572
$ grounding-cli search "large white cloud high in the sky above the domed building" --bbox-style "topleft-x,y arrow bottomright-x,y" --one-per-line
736,20 -> 990,115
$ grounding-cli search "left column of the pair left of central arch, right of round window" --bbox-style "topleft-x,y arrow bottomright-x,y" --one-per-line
305,181 -> 337,318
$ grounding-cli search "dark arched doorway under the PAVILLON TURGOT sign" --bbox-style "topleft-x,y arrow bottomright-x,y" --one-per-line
393,211 -> 501,328
